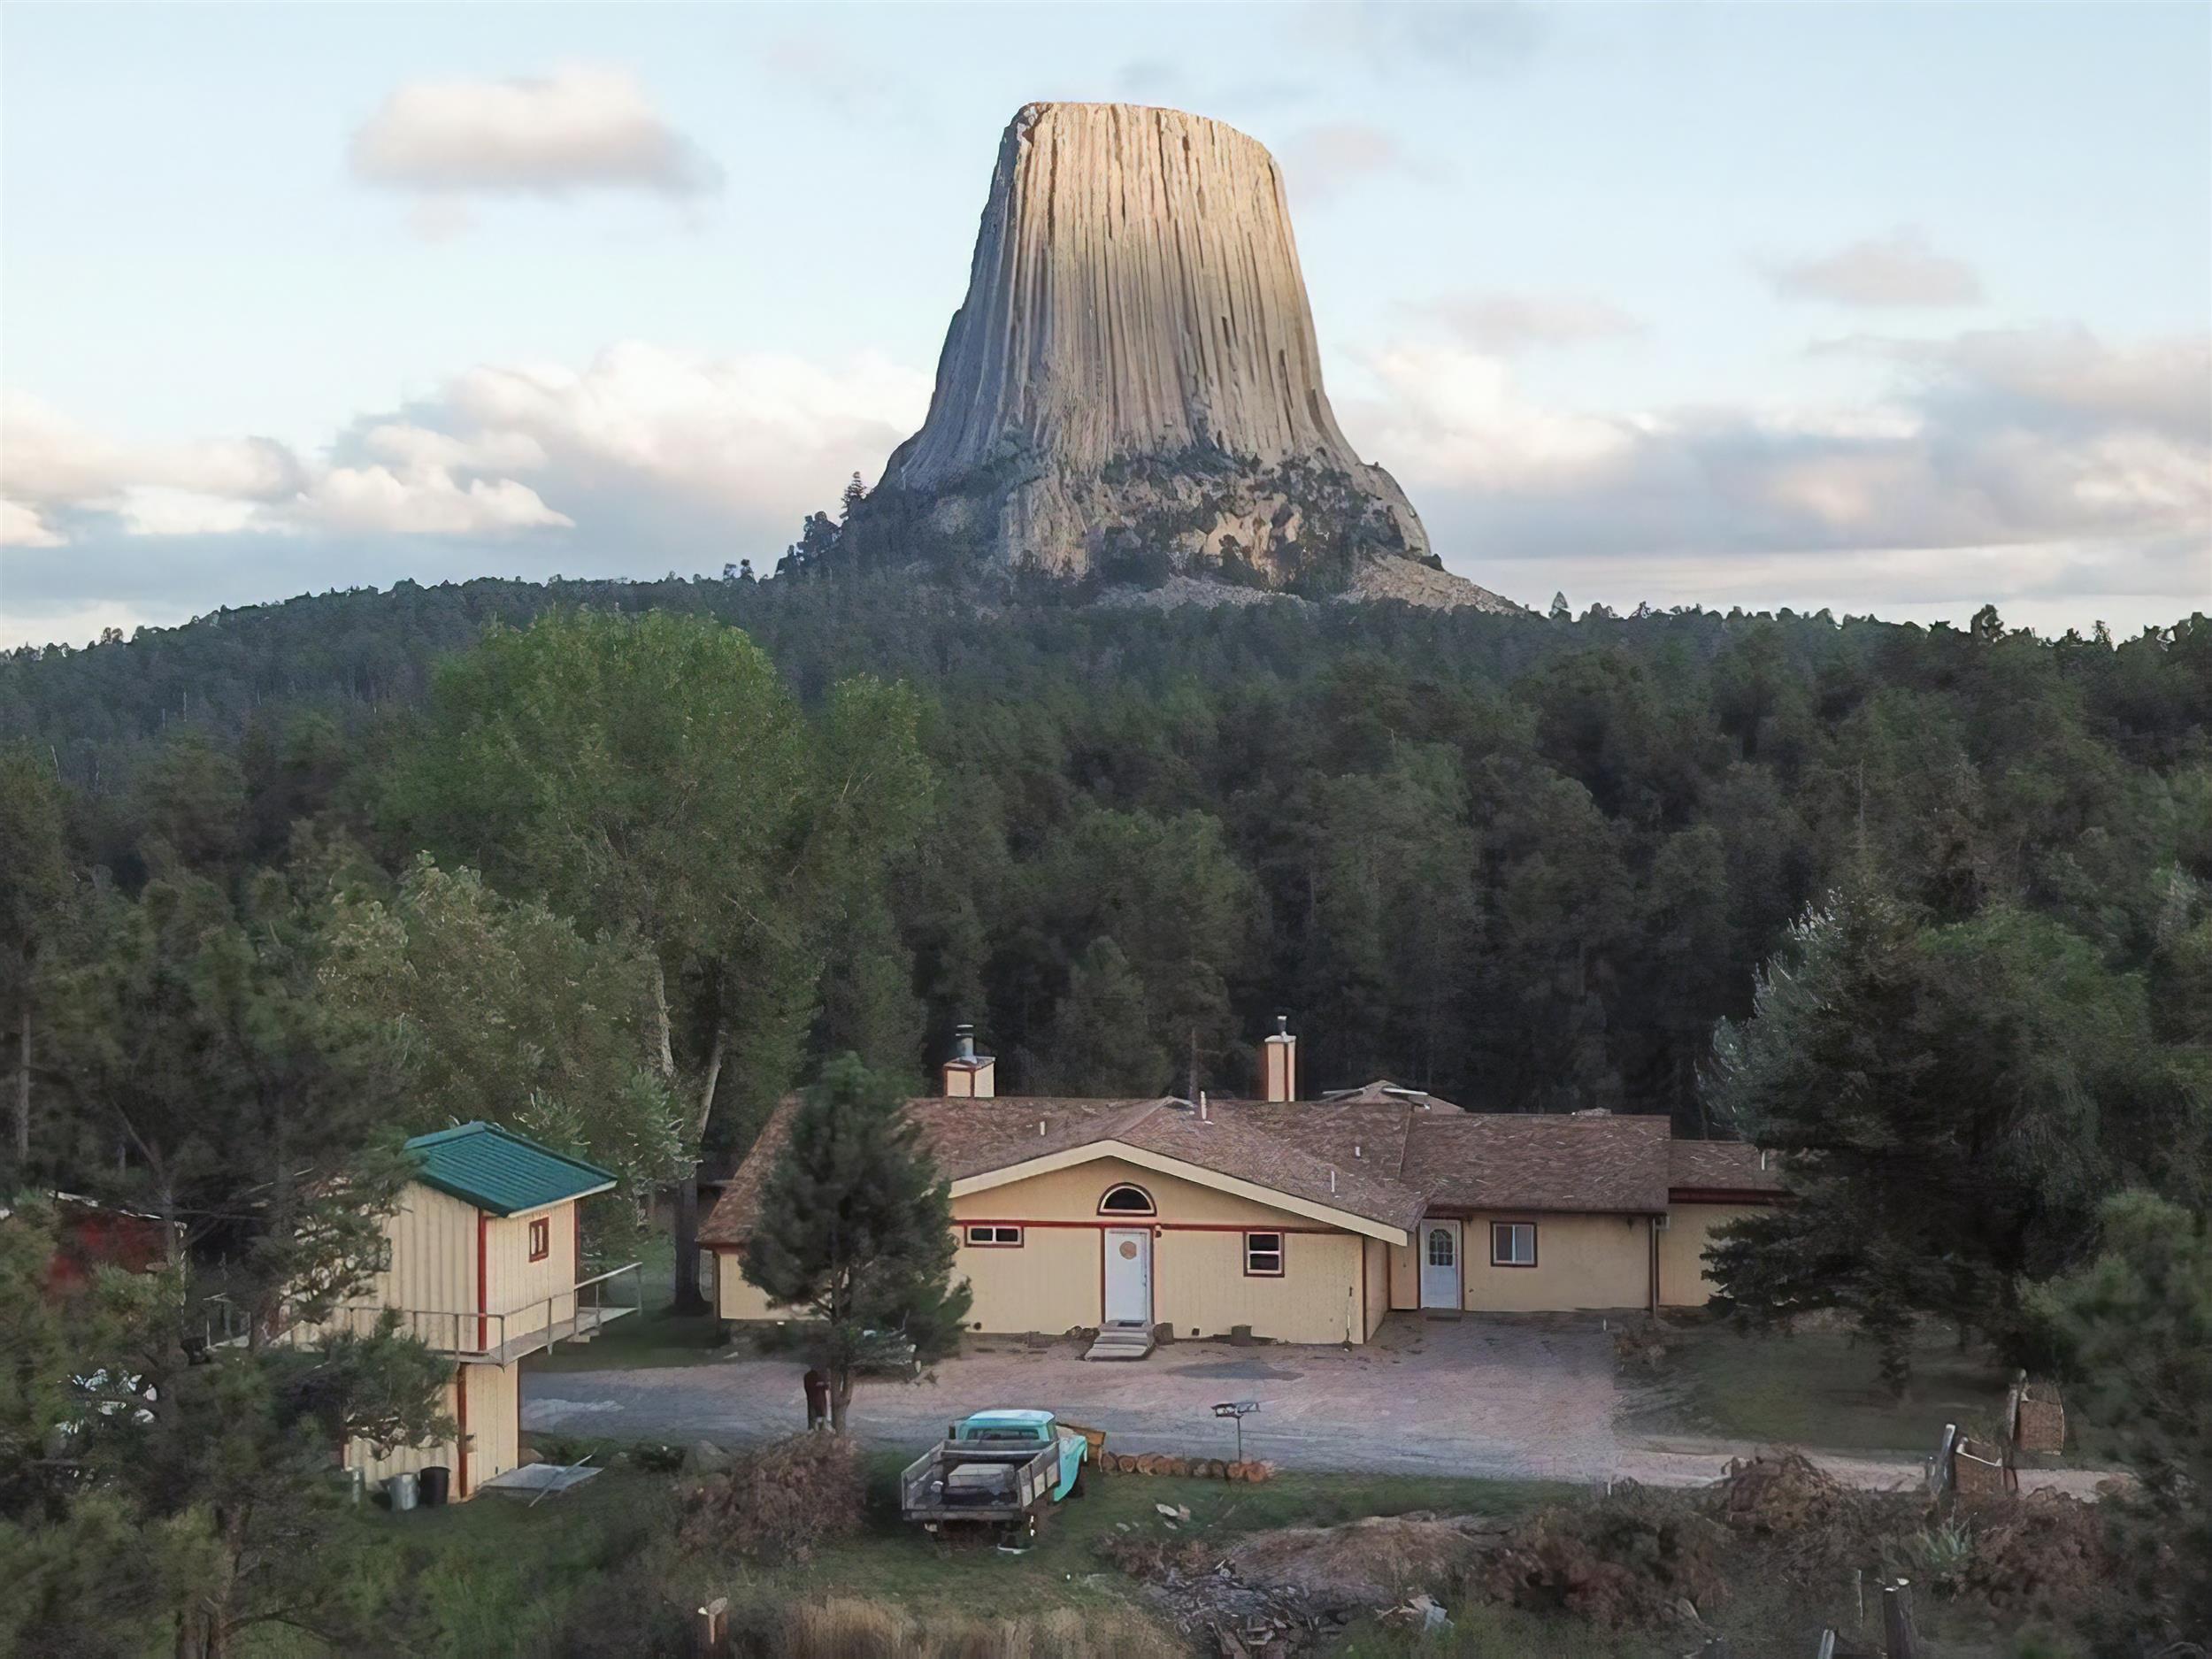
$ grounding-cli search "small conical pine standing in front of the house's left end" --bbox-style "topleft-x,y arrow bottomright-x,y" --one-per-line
743,1056 -> 969,1433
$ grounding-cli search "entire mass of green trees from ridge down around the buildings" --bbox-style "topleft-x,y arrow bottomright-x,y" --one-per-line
0,573 -> 2212,1659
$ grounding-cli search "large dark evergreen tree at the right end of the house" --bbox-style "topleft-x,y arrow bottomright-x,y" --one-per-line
1708,874 -> 2168,1389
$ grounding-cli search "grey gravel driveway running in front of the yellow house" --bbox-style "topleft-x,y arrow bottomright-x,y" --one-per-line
522,1314 -> 2097,1495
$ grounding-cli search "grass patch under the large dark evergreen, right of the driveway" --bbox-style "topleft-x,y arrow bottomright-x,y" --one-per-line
1624,1325 -> 2008,1455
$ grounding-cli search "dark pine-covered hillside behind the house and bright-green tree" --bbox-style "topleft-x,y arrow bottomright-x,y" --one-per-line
0,578 -> 2212,1122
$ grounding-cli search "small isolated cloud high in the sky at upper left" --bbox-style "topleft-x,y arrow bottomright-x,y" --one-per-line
352,66 -> 724,200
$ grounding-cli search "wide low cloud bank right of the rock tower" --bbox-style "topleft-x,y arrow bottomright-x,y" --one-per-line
1345,319 -> 2212,626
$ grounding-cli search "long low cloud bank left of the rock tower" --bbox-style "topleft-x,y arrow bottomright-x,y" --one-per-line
0,343 -> 929,566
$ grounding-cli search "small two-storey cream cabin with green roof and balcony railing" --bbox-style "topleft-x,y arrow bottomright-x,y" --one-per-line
296,1124 -> 637,1500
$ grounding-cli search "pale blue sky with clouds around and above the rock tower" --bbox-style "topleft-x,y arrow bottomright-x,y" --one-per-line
0,0 -> 2212,646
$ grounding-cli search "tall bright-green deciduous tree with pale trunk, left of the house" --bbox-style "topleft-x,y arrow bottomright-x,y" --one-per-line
394,611 -> 929,1308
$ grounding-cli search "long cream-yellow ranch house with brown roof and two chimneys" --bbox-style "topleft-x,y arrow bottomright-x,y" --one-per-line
699,1031 -> 1781,1358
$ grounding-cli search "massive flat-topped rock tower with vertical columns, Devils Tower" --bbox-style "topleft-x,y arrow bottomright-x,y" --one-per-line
861,104 -> 1449,591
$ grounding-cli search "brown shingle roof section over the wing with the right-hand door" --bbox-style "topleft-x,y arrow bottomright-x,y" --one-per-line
1402,1113 -> 1668,1215
